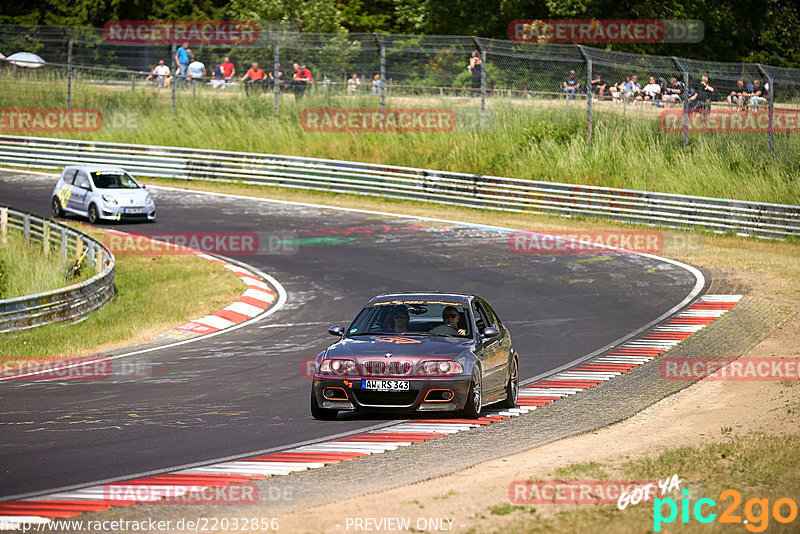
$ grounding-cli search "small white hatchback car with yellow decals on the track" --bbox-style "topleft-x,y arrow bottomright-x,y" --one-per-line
51,165 -> 156,224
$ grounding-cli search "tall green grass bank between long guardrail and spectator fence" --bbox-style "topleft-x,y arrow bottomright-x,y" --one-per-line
6,79 -> 800,204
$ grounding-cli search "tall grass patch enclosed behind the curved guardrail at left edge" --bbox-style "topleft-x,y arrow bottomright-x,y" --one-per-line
0,229 -> 92,300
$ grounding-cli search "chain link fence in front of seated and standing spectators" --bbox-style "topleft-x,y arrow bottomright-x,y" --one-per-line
0,24 -> 800,155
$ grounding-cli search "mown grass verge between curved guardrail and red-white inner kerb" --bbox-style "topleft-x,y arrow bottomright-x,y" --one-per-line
0,227 -> 244,364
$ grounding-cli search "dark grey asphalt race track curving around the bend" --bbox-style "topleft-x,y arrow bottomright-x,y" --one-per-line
0,171 -> 696,500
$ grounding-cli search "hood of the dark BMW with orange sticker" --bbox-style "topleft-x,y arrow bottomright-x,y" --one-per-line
326,334 -> 473,360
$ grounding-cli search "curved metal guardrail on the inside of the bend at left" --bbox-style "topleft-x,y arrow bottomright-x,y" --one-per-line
0,206 -> 116,333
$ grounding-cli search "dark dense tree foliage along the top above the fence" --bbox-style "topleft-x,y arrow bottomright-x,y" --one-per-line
0,0 -> 800,67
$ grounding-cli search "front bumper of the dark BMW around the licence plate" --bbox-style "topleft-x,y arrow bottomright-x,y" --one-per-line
312,376 -> 471,413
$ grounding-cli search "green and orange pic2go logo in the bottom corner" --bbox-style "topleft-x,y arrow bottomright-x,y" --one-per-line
653,489 -> 797,532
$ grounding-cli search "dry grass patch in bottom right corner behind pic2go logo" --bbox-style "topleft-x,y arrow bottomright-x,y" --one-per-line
486,433 -> 800,534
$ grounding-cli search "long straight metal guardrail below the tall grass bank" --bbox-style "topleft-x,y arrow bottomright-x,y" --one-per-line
0,136 -> 800,239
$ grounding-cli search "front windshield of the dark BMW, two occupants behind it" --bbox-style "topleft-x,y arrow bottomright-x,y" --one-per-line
347,299 -> 472,337
